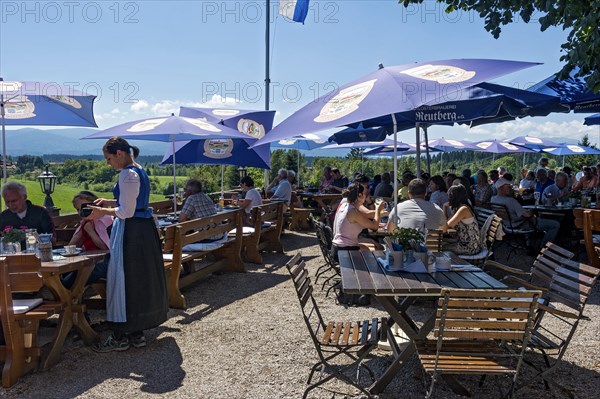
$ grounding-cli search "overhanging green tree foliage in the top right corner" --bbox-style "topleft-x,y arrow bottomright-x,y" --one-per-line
399,0 -> 600,92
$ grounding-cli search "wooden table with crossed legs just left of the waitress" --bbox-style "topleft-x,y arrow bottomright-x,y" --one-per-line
40,251 -> 108,370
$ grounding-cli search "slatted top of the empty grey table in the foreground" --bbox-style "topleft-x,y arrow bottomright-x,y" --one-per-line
338,251 -> 507,296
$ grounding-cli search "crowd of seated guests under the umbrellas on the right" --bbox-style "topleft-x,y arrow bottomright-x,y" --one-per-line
320,157 -> 600,260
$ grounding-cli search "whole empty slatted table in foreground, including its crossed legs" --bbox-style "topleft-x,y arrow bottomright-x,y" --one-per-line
338,251 -> 507,394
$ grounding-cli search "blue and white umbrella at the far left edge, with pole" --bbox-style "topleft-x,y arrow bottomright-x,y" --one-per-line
0,78 -> 98,182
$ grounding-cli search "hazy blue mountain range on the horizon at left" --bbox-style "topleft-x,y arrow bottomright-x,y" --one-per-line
6,128 -> 168,156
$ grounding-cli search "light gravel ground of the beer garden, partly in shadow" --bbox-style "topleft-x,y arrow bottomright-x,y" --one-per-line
0,233 -> 600,398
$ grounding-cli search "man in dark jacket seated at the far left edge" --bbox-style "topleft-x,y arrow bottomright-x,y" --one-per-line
0,181 -> 55,248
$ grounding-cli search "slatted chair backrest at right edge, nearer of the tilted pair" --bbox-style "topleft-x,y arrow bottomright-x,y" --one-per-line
547,259 -> 600,314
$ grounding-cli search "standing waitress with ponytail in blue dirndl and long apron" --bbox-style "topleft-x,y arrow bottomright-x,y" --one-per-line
87,137 -> 169,352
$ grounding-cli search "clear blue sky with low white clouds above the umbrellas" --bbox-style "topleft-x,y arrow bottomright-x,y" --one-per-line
0,0 -> 600,151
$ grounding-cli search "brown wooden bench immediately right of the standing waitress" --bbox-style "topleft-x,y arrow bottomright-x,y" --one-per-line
163,210 -> 245,309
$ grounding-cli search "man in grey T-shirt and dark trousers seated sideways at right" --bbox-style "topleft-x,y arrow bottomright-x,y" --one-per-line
491,178 -> 560,248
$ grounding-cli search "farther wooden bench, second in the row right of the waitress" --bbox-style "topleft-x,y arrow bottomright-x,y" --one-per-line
244,202 -> 284,264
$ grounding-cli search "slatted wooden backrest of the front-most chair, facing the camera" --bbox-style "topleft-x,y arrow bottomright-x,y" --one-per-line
434,289 -> 541,346
